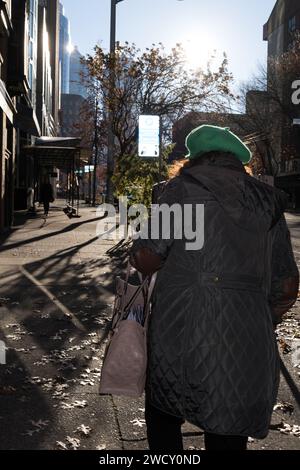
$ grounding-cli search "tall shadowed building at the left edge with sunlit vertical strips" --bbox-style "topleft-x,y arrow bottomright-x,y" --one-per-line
0,0 -> 60,232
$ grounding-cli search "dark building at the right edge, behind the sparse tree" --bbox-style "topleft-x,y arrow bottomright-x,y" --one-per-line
263,0 -> 300,208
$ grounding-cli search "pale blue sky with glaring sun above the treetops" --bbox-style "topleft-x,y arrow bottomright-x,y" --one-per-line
62,0 -> 276,81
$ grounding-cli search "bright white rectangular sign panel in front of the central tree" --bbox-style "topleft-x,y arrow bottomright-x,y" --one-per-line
139,115 -> 160,158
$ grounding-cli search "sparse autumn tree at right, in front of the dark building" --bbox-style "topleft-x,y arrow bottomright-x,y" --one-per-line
233,33 -> 300,176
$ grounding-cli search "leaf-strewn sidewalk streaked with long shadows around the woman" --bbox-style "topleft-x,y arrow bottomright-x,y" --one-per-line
0,203 -> 300,450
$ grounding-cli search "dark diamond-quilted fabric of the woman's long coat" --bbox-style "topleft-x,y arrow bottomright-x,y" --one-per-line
134,164 -> 297,438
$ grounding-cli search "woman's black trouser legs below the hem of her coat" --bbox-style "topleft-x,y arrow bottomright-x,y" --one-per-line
146,402 -> 248,453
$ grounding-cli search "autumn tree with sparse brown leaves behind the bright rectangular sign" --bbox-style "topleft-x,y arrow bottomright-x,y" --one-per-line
79,43 -> 232,205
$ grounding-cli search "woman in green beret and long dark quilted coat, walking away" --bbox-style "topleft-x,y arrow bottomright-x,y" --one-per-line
131,126 -> 299,452
